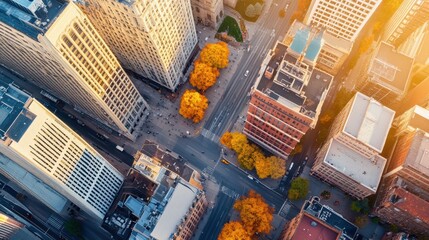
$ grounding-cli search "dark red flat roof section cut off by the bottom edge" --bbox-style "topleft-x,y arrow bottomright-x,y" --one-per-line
290,213 -> 341,240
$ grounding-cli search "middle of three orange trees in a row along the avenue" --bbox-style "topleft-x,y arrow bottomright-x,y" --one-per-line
189,61 -> 219,92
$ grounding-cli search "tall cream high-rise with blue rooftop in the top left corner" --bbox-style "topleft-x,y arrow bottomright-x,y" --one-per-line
0,0 -> 148,140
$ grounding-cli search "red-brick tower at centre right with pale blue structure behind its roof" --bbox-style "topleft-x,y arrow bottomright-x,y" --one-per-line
243,37 -> 332,158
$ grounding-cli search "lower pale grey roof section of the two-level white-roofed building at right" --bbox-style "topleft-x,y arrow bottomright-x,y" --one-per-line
323,138 -> 386,191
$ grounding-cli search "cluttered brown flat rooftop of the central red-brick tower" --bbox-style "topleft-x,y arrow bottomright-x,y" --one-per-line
256,42 -> 333,118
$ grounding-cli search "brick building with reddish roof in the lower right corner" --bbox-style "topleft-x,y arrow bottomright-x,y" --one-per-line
374,176 -> 429,236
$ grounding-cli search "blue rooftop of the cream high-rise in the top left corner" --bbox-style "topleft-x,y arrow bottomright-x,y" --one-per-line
0,0 -> 68,40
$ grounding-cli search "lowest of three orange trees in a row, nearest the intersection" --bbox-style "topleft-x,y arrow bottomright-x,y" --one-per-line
179,90 -> 208,123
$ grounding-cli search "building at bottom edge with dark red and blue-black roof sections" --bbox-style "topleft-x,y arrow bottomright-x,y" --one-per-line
279,197 -> 358,240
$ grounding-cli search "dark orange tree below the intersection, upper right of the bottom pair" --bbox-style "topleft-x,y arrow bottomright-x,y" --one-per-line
234,190 -> 273,236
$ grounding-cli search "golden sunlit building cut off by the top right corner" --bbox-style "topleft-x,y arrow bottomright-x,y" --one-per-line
382,0 -> 429,47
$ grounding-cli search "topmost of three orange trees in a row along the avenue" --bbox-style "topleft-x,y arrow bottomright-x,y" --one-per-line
200,42 -> 229,69
